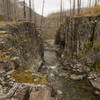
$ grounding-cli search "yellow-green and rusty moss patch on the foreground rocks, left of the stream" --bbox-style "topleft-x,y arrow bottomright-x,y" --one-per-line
12,71 -> 50,85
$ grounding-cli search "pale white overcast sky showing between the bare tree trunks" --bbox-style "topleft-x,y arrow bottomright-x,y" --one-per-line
21,0 -> 91,16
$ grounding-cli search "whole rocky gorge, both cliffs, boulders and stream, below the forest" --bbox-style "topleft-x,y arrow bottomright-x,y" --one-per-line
0,16 -> 100,100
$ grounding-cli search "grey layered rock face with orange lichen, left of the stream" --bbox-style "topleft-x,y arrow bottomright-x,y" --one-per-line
0,22 -> 43,71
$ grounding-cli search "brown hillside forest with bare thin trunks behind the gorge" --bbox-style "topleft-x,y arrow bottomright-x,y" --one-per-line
0,0 -> 100,39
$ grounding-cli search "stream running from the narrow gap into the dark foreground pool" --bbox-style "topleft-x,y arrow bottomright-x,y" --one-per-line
44,41 -> 100,100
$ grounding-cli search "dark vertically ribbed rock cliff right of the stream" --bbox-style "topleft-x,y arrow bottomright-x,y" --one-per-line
55,15 -> 100,68
